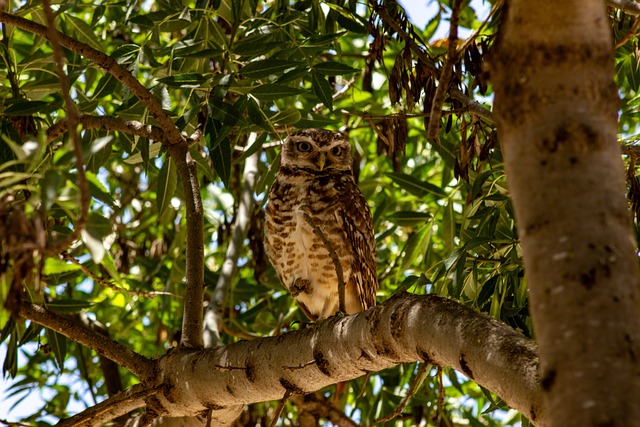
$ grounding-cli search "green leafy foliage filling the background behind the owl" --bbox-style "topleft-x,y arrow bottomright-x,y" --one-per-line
0,0 -> 640,425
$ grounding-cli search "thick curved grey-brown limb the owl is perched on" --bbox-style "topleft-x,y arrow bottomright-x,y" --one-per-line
158,294 -> 545,426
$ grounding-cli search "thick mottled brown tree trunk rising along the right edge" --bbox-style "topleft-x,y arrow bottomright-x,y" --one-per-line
492,0 -> 640,426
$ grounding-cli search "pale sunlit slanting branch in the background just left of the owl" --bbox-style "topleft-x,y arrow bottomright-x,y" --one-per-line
203,142 -> 260,347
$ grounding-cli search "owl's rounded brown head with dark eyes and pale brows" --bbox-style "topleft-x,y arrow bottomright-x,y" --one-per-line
280,129 -> 351,171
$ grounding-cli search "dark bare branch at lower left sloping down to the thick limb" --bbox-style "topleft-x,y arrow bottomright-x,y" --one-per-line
18,302 -> 154,382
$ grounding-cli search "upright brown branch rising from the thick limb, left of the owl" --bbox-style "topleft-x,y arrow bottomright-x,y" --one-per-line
168,144 -> 204,347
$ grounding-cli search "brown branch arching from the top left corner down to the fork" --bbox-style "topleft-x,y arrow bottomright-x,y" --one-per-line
0,11 -> 185,144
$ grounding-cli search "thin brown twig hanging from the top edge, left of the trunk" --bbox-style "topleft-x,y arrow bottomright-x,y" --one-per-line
427,0 -> 462,141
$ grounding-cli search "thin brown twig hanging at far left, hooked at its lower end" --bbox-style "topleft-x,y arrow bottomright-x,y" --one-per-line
42,0 -> 91,253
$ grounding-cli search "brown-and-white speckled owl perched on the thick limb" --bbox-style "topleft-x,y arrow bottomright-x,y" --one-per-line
265,129 -> 378,321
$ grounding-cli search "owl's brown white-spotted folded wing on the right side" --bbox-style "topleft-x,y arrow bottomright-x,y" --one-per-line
338,180 -> 378,310
